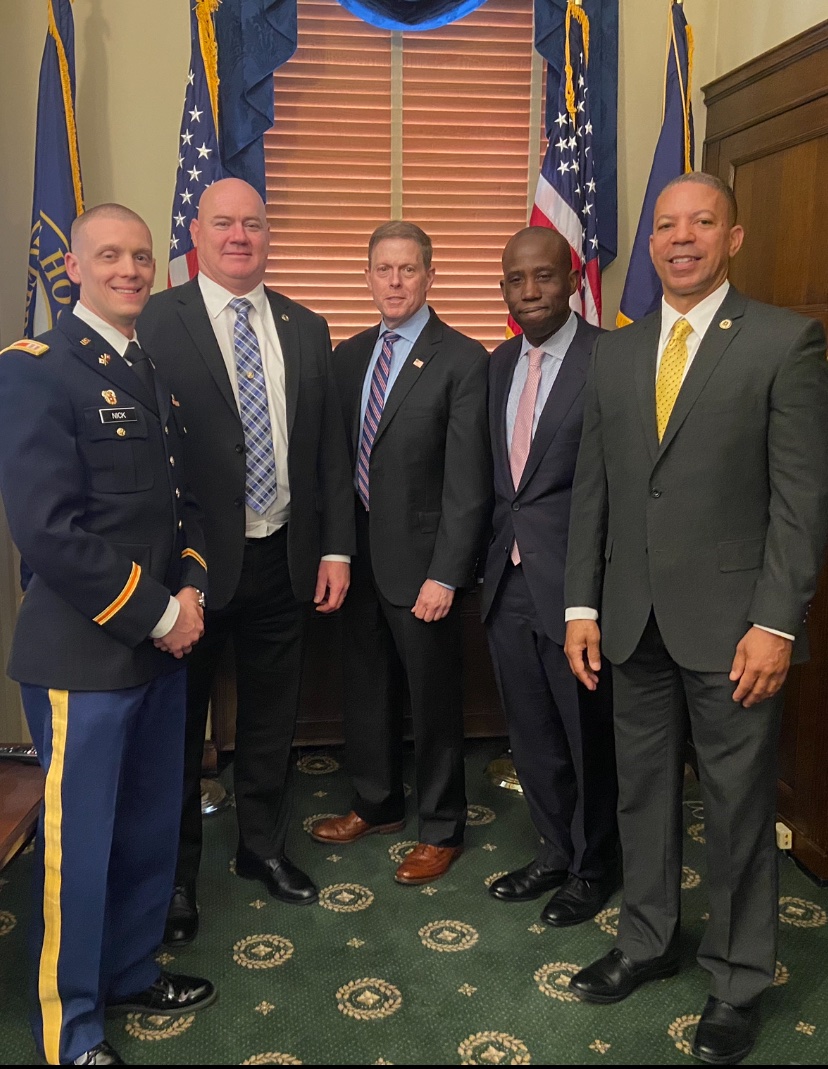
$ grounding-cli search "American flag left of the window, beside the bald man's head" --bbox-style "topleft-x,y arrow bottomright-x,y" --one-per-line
167,0 -> 223,285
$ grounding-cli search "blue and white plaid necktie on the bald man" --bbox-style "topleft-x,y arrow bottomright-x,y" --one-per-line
230,297 -> 276,513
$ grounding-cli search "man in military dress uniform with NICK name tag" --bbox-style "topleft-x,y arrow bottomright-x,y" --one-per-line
0,204 -> 216,1065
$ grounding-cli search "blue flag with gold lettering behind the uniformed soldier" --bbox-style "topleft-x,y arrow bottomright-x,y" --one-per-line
25,0 -> 83,338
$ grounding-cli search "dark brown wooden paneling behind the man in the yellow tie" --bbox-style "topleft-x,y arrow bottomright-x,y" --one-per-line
703,20 -> 828,880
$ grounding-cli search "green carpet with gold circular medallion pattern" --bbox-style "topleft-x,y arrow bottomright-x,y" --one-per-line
0,741 -> 828,1066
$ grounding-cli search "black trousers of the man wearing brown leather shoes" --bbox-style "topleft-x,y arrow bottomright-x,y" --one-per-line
343,501 -> 466,847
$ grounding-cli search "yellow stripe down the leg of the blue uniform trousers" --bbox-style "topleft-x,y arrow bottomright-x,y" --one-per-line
37,691 -> 69,1065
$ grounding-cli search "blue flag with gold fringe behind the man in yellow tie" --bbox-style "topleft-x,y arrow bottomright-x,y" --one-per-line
615,0 -> 696,327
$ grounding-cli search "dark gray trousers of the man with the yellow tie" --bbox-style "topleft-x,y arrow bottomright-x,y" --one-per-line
612,615 -> 782,1006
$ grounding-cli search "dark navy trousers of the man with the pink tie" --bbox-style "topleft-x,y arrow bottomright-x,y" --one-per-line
487,563 -> 618,880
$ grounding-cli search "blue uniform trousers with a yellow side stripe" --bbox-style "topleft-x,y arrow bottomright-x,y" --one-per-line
20,670 -> 185,1065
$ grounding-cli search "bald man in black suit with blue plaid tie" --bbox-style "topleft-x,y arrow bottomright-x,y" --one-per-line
139,179 -> 354,944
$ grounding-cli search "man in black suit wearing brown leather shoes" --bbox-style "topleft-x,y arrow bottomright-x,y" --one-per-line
312,222 -> 491,884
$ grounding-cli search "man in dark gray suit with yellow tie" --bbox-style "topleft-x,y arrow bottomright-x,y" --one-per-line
565,173 -> 828,1064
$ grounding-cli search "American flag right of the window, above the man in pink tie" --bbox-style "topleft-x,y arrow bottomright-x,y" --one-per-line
510,0 -> 600,332
